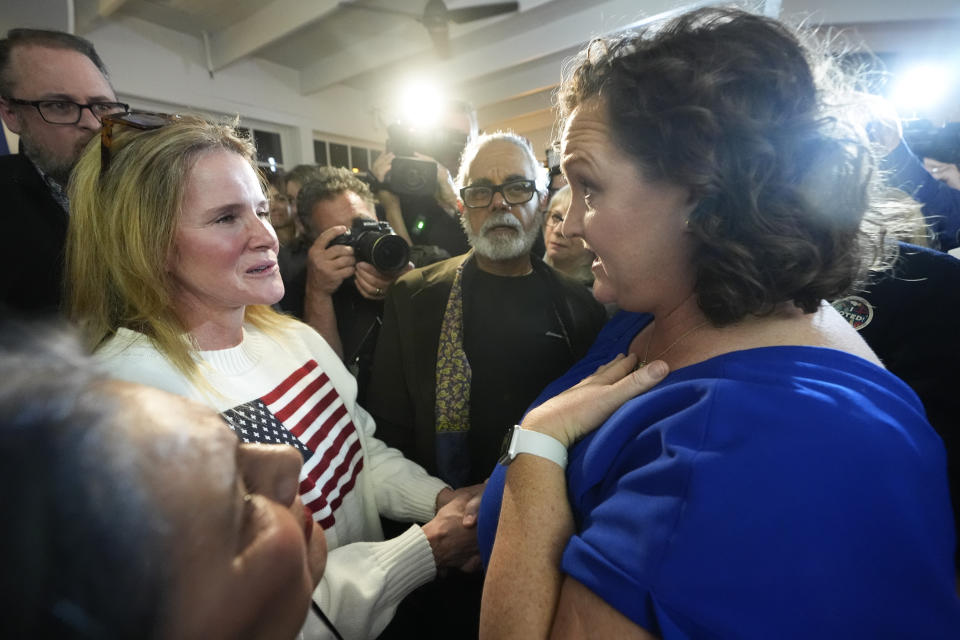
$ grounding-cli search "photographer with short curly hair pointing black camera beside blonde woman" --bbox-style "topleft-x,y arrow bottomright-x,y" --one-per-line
279,167 -> 413,403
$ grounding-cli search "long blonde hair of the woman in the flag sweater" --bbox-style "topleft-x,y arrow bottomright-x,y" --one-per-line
64,115 -> 292,381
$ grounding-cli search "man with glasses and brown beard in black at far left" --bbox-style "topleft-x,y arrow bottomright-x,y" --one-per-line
0,29 -> 128,313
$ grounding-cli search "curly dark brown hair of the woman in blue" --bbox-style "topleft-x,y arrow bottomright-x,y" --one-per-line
559,9 -> 884,326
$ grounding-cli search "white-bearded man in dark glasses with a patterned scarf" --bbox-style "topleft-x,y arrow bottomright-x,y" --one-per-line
367,132 -> 605,638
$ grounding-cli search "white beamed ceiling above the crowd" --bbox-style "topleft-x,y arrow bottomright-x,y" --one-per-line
75,0 -> 960,135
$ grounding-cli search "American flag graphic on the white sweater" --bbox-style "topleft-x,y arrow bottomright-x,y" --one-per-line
222,360 -> 363,529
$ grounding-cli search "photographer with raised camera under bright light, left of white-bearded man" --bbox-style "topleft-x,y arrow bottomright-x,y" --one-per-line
370,100 -> 478,267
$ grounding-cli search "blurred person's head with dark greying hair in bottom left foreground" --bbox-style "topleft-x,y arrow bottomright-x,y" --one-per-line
0,324 -> 326,639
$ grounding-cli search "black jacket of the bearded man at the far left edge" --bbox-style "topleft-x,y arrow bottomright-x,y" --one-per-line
0,155 -> 69,315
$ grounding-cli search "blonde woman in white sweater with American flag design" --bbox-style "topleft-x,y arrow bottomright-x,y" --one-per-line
67,113 -> 476,638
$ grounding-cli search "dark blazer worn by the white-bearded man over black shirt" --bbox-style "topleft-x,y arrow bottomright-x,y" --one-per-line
366,253 -> 606,475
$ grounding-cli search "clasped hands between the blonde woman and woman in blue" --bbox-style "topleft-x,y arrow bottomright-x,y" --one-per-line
423,483 -> 486,573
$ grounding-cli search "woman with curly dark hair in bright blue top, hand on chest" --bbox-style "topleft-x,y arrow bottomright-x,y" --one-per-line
480,9 -> 960,638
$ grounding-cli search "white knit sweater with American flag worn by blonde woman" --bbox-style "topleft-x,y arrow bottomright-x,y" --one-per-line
96,324 -> 446,638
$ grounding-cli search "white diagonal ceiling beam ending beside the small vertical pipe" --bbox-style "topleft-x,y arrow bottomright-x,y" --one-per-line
210,0 -> 338,70
